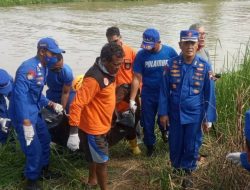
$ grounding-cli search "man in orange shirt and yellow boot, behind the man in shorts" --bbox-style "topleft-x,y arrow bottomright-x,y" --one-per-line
106,26 -> 141,155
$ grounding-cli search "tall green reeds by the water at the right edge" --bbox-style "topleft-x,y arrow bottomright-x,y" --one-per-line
215,40 -> 250,145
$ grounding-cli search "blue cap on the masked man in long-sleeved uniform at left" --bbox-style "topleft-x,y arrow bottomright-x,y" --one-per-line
37,37 -> 65,54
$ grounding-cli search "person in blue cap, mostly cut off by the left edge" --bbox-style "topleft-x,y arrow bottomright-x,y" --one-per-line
0,69 -> 13,144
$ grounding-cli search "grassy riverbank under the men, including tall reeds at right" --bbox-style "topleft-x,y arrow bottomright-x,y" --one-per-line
0,45 -> 250,190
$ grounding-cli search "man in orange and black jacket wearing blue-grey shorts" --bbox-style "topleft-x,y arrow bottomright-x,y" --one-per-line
67,43 -> 124,190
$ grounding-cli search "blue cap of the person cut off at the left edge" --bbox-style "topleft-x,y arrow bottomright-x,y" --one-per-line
0,69 -> 12,96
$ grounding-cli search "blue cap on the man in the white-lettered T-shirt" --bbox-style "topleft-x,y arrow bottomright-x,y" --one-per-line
141,28 -> 160,50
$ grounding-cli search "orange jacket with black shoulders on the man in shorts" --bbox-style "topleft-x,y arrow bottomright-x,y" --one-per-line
69,59 -> 116,135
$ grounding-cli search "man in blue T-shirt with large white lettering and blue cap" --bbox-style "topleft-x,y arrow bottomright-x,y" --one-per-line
130,28 -> 177,157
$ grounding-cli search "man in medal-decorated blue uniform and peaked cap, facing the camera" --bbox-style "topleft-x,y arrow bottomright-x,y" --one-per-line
158,30 -> 216,186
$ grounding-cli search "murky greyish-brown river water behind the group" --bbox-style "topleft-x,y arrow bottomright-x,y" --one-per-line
0,0 -> 250,75
